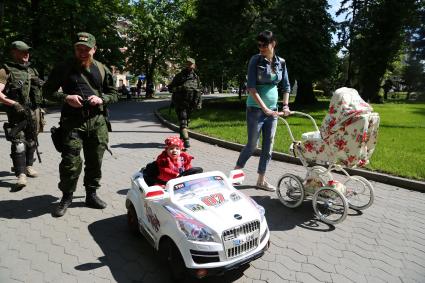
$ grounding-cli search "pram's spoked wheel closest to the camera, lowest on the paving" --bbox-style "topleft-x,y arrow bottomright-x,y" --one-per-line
313,187 -> 348,224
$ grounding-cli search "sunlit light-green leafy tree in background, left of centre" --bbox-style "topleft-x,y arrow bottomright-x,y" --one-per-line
127,0 -> 192,95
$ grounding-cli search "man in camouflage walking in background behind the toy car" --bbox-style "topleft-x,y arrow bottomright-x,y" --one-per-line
168,58 -> 201,148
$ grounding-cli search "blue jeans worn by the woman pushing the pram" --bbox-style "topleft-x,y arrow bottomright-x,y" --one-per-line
236,107 -> 277,174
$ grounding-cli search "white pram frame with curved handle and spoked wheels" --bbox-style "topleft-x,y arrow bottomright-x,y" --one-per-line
276,111 -> 374,225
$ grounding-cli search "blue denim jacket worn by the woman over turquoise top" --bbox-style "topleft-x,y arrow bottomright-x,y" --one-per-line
243,54 -> 291,93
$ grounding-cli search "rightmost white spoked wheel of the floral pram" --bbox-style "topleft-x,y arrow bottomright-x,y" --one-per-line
344,176 -> 375,210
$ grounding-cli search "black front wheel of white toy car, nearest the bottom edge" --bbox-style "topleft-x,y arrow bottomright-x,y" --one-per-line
159,239 -> 188,282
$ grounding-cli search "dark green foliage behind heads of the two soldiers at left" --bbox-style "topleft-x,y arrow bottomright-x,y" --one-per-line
0,0 -> 129,74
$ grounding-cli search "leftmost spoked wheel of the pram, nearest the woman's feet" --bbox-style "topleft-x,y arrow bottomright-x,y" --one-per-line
276,174 -> 304,208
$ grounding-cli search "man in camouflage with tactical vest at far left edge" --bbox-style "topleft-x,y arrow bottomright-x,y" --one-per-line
0,41 -> 42,189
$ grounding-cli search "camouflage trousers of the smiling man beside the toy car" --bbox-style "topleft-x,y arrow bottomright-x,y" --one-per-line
58,115 -> 108,193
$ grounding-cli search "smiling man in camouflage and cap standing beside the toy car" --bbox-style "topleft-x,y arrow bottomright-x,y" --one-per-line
43,32 -> 118,217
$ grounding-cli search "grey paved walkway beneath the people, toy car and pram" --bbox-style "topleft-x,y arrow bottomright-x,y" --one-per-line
0,100 -> 425,283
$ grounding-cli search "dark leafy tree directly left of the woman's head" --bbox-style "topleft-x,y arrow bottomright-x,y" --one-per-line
183,0 -> 271,95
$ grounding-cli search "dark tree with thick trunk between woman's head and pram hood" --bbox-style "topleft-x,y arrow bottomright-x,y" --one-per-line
268,0 -> 336,104
